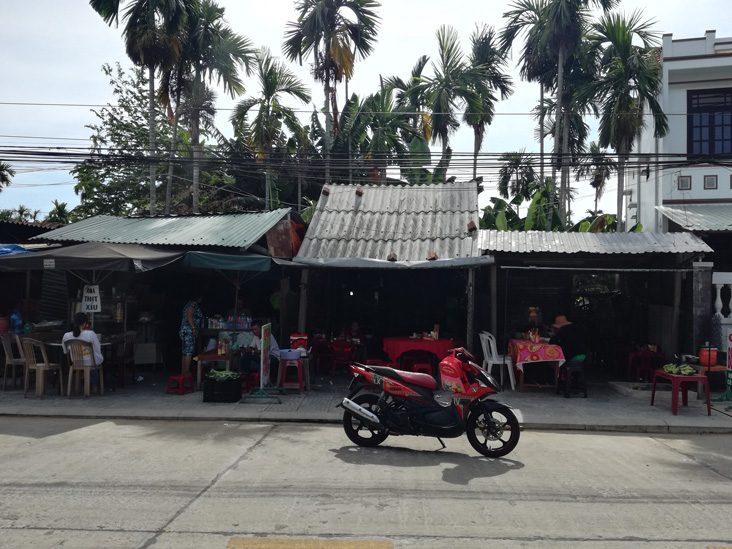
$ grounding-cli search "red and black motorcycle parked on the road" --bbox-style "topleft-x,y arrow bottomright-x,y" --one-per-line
340,347 -> 521,457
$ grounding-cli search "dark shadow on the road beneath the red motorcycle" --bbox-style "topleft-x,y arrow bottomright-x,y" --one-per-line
331,441 -> 524,486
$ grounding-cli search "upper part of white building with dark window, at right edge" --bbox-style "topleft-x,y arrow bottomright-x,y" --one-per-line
625,30 -> 732,232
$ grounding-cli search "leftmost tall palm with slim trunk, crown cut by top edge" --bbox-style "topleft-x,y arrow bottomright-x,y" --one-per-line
89,0 -> 192,215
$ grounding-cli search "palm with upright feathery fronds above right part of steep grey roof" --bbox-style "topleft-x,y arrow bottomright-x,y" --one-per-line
420,25 -> 491,156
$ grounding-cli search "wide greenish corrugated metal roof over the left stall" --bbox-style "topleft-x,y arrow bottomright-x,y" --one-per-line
34,208 -> 290,249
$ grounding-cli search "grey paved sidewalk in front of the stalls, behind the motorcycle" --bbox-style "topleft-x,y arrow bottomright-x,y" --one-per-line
0,372 -> 732,433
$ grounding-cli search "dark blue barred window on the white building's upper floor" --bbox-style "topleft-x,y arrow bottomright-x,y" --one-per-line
686,88 -> 732,156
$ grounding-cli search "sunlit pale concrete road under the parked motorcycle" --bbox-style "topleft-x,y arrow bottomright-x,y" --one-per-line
0,417 -> 732,549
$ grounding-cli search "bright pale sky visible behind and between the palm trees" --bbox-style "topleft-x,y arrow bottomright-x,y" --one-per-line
0,0 -> 732,219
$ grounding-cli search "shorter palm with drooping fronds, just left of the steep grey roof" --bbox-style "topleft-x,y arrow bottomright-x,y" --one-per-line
231,48 -> 310,210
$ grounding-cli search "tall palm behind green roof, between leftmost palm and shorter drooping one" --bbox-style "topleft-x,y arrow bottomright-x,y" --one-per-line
183,0 -> 254,213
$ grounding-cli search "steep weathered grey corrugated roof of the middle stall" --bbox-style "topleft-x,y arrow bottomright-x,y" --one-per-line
296,181 -> 480,262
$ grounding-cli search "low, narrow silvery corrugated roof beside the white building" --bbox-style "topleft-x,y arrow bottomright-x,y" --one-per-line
478,230 -> 712,254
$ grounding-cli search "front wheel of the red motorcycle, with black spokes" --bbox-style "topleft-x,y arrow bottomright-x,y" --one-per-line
466,406 -> 521,457
